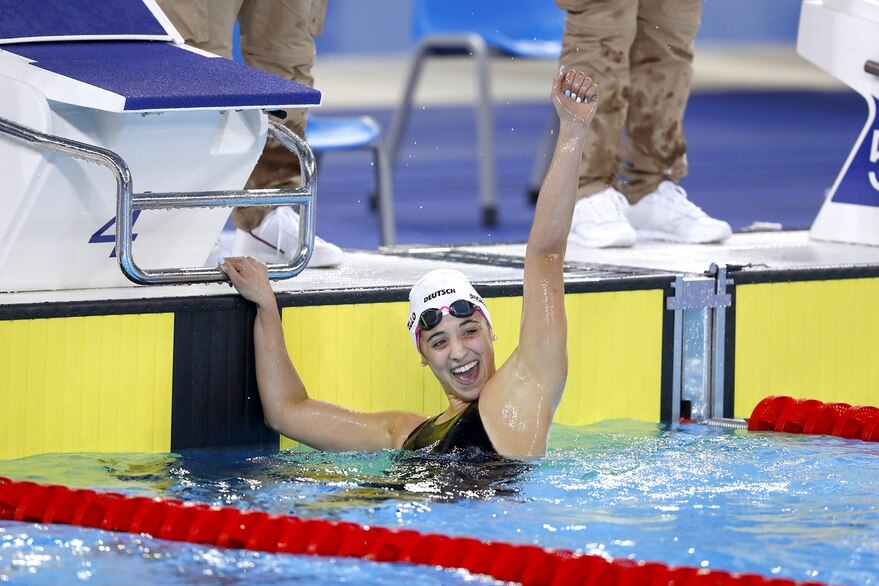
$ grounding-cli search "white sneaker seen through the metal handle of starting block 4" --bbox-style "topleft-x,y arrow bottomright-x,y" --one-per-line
232,206 -> 345,268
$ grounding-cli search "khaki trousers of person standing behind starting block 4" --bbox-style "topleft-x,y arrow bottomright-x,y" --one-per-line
157,0 -> 327,231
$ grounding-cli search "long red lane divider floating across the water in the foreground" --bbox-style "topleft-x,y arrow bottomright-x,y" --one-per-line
0,477 -> 821,586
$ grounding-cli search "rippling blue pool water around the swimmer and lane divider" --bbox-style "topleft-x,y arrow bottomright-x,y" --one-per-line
0,421 -> 879,585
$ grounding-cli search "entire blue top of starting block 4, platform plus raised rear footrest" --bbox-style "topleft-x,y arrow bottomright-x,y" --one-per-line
0,0 -> 321,112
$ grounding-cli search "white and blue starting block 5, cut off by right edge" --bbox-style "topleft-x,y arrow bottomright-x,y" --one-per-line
797,0 -> 879,246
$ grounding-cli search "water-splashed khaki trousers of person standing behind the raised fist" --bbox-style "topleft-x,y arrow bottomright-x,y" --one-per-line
556,0 -> 703,203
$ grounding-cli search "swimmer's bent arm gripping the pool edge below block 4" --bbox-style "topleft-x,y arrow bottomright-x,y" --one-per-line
219,257 -> 425,451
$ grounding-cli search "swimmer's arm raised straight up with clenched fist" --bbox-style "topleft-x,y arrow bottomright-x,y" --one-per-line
480,70 -> 598,456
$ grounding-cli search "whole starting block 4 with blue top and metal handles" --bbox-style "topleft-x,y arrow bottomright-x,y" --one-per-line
0,0 -> 321,291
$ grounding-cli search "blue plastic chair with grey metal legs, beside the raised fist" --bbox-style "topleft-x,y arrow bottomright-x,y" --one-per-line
388,0 -> 565,225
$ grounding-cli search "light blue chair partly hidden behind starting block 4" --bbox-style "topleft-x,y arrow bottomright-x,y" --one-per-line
305,114 -> 396,246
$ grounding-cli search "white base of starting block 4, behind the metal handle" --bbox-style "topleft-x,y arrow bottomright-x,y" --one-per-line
0,76 -> 267,291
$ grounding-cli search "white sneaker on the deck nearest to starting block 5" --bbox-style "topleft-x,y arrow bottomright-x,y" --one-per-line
628,181 -> 732,244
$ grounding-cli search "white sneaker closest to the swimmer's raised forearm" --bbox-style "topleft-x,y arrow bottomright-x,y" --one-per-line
568,187 -> 635,248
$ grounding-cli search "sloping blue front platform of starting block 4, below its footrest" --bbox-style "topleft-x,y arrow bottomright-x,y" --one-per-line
2,41 -> 321,111
